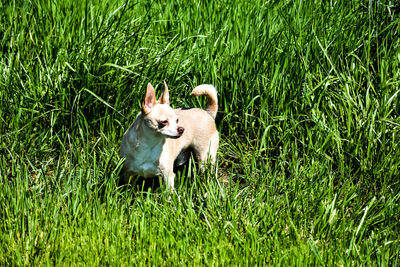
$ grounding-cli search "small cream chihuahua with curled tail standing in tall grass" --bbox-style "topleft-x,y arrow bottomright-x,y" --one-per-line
120,81 -> 219,191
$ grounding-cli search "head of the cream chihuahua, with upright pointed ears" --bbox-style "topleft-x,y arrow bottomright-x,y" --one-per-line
142,82 -> 185,138
